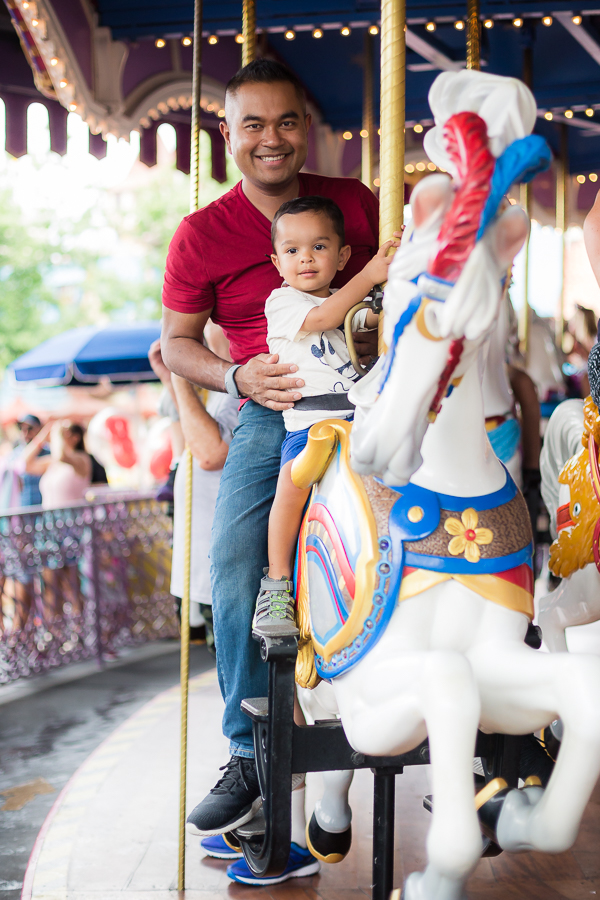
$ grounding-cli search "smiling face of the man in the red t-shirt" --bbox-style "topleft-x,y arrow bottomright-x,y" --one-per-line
221,81 -> 310,187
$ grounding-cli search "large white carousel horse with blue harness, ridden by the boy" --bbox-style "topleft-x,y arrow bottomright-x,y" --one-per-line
293,71 -> 600,900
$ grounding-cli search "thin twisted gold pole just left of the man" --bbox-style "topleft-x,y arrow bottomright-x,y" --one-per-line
177,0 -> 202,891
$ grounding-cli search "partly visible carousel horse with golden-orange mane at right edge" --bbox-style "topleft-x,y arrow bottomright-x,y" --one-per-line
538,397 -> 600,652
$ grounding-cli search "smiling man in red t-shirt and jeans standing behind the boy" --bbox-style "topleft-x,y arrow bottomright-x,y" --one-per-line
162,59 -> 379,859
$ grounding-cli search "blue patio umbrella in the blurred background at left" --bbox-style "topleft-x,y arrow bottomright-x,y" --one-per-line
8,322 -> 160,385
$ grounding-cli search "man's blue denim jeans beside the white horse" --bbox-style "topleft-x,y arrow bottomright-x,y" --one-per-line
210,400 -> 285,757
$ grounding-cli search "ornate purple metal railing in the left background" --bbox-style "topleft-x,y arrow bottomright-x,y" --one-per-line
0,494 -> 179,691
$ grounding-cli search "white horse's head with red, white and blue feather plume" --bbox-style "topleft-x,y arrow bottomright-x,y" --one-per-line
350,72 -> 536,485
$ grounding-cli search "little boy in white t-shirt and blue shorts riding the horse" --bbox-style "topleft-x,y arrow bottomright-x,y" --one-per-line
252,197 -> 399,636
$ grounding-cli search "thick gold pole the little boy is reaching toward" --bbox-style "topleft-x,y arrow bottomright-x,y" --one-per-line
379,0 -> 406,353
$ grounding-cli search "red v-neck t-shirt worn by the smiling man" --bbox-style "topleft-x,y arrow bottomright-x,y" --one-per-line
163,173 -> 379,364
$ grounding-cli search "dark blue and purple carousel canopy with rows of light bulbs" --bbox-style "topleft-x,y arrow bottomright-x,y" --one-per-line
0,0 -> 600,180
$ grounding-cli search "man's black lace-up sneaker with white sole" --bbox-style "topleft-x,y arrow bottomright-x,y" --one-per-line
186,756 -> 262,834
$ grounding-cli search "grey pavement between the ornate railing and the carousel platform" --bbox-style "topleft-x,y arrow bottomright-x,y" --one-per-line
0,641 -> 214,900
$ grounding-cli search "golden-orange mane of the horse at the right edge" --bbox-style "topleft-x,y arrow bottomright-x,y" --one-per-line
549,397 -> 600,578
